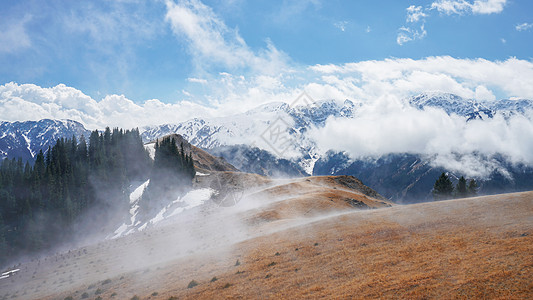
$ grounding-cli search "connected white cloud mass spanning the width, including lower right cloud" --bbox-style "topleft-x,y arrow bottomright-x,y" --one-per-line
0,56 -> 533,177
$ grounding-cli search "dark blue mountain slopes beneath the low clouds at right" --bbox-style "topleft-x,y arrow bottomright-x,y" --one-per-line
313,151 -> 533,203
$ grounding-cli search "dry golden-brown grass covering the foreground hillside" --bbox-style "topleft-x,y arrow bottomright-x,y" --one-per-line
0,189 -> 533,299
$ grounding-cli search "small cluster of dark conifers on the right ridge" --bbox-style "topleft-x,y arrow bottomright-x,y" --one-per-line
432,172 -> 478,200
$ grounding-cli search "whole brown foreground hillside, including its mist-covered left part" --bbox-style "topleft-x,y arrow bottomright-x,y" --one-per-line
0,184 -> 533,299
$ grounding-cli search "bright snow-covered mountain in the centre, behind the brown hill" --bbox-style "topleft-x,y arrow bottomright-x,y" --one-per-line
141,100 -> 356,174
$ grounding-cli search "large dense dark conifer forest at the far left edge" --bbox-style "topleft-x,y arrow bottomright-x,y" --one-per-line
0,127 -> 152,263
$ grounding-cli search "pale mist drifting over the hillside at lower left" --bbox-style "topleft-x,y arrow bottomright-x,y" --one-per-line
0,165 -> 378,298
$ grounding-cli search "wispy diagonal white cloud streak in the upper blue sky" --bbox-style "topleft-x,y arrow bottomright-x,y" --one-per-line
166,0 -> 287,73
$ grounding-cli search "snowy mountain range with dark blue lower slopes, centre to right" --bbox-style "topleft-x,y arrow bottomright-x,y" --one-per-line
0,92 -> 533,201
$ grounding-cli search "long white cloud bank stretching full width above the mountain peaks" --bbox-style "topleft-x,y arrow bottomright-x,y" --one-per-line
0,56 -> 533,129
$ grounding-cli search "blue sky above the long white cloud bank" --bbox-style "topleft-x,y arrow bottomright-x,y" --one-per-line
0,0 -> 533,103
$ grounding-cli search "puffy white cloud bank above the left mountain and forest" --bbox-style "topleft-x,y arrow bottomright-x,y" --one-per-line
0,83 -> 214,129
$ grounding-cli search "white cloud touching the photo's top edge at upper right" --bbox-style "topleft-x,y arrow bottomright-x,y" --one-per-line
431,0 -> 507,15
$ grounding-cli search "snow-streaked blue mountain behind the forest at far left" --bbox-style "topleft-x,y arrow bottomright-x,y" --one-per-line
0,119 -> 90,161
